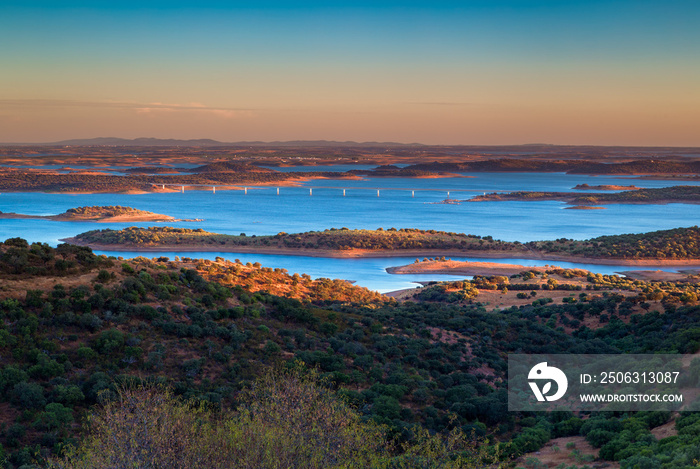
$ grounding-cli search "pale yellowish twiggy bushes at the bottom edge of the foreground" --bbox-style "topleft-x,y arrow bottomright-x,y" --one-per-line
49,369 -> 500,469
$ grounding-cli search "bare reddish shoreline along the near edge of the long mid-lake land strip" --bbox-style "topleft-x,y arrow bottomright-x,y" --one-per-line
59,238 -> 700,267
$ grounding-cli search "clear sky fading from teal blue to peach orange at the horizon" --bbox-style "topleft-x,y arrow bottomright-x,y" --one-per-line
0,0 -> 700,146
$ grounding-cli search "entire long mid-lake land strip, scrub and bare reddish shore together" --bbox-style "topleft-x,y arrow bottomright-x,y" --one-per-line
62,226 -> 700,265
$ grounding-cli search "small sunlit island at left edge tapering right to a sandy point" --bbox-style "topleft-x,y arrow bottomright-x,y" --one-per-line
0,205 -> 202,223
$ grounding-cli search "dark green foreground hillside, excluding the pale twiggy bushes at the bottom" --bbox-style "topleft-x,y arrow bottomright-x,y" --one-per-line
0,238 -> 700,469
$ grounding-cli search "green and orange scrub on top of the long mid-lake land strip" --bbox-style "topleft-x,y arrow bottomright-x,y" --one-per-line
72,226 -> 700,260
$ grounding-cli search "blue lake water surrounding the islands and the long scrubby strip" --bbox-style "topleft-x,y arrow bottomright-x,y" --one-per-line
0,167 -> 700,291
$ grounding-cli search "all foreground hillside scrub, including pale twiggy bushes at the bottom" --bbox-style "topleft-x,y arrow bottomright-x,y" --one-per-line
0,238 -> 700,469
